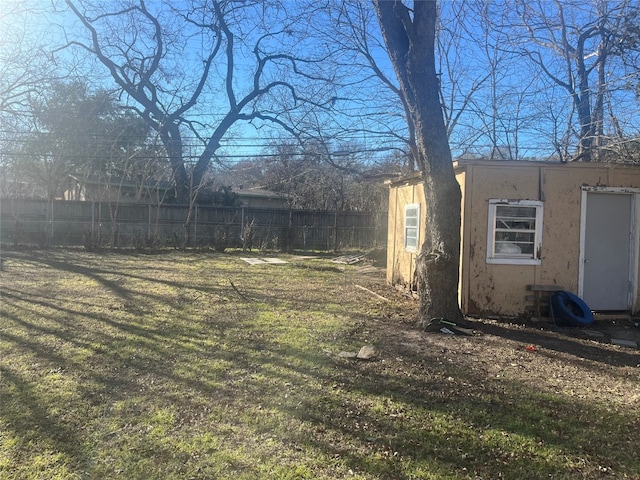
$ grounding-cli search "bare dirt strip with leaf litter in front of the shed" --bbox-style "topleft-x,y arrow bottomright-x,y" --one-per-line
350,272 -> 640,408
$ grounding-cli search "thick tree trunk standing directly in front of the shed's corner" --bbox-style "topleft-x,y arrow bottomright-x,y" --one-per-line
374,0 -> 462,325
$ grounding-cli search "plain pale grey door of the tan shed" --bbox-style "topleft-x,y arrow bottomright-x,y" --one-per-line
582,192 -> 633,310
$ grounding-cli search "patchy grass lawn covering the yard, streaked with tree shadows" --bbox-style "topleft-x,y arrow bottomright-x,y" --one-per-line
0,250 -> 640,480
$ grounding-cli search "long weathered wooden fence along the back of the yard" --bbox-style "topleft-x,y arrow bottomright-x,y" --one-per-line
0,199 -> 387,251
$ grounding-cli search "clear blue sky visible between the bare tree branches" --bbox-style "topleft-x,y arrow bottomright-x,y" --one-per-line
0,0 -> 640,164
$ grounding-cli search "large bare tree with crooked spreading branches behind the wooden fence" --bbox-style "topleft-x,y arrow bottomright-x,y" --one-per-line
65,0 -> 331,203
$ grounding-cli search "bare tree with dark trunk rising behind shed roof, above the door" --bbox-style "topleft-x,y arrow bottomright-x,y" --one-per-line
498,0 -> 638,161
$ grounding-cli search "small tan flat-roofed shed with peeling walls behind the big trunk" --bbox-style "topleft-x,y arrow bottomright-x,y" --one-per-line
387,160 -> 640,316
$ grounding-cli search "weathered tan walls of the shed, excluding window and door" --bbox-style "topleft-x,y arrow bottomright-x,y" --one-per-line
387,161 -> 640,316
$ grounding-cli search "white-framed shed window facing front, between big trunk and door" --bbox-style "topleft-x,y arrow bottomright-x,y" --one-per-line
487,199 -> 542,265
